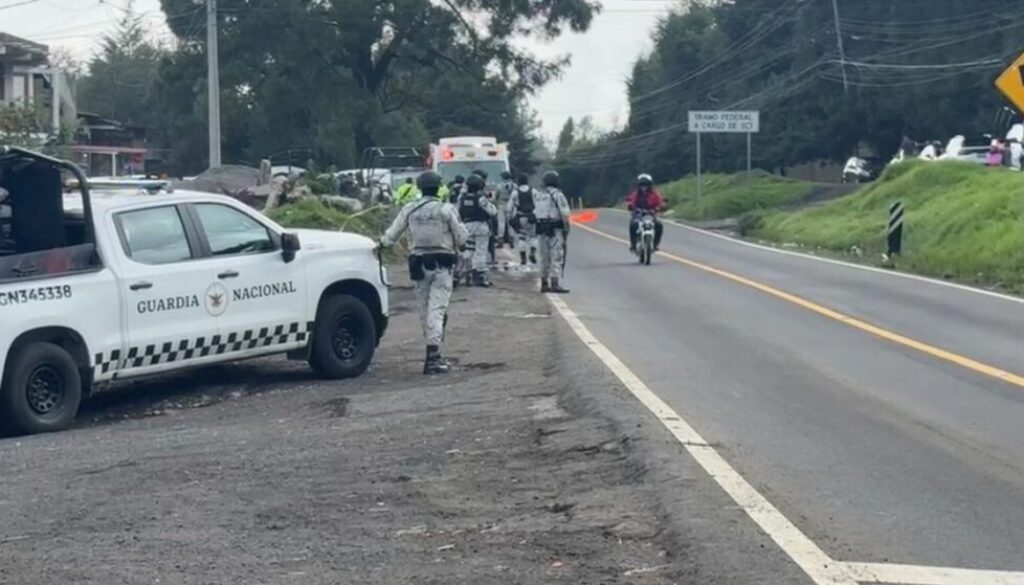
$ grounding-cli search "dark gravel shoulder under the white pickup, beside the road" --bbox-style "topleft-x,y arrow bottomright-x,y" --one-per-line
0,266 -> 800,585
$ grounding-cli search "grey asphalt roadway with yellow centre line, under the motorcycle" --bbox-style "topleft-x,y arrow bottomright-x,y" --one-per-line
565,210 -> 1024,571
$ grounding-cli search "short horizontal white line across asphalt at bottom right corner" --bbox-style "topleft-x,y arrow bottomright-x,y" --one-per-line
845,562 -> 1024,585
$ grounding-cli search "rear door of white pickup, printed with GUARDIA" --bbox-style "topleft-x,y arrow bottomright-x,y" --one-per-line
113,204 -> 223,377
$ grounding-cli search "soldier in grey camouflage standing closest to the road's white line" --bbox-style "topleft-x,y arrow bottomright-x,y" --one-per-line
534,171 -> 569,293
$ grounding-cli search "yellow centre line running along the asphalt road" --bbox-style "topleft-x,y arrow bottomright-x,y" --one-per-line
574,223 -> 1024,388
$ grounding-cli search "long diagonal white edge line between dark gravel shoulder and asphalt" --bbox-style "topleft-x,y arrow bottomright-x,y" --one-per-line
548,295 -> 857,585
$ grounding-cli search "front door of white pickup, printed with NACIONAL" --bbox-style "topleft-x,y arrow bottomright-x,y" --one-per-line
189,203 -> 311,357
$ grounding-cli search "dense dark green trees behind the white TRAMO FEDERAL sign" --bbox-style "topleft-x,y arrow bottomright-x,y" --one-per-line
558,0 -> 1024,197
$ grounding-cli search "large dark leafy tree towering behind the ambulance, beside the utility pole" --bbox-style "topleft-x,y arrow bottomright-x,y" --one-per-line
155,0 -> 593,169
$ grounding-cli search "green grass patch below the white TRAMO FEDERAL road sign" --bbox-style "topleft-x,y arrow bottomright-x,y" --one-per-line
658,171 -> 815,221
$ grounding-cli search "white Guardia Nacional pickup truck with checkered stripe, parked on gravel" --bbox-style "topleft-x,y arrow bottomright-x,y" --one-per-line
0,148 -> 388,433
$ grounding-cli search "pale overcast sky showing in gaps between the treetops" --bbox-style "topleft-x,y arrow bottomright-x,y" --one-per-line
0,0 -> 675,137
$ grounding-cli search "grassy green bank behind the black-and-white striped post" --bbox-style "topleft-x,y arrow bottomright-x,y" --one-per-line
753,162 -> 1024,292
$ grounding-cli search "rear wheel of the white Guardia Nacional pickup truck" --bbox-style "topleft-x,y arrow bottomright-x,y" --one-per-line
0,343 -> 82,434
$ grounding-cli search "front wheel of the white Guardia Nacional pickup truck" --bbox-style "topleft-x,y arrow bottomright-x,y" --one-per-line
309,294 -> 377,379
